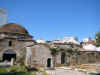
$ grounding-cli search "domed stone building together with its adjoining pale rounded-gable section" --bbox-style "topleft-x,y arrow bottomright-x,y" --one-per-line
0,23 -> 53,67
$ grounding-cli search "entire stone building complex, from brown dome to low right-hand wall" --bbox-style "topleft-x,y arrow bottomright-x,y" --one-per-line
0,23 -> 100,68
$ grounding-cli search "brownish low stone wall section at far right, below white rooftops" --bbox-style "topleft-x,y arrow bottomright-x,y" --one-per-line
76,51 -> 100,64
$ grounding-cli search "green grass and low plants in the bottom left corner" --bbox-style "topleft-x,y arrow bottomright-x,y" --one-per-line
0,65 -> 36,75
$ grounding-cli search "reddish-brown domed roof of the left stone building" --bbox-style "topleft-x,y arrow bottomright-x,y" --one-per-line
0,23 -> 28,34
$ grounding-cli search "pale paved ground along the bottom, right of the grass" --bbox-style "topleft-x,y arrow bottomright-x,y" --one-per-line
47,68 -> 87,75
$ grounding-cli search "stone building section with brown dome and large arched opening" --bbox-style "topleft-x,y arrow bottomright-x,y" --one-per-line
0,23 -> 34,61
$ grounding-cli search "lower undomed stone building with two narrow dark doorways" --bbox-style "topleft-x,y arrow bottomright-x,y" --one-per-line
32,42 -> 100,67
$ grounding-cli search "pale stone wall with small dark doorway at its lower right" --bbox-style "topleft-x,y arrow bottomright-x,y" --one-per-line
32,44 -> 53,67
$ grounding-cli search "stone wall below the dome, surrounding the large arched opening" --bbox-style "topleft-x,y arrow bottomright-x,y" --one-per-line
0,39 -> 32,61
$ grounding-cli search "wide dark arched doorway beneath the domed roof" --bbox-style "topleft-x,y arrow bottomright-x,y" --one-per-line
3,50 -> 16,61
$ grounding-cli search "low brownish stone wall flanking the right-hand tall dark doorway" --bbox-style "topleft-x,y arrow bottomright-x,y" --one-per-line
56,51 -> 100,65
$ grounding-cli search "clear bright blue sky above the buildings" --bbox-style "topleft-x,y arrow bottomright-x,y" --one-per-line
0,0 -> 100,40
